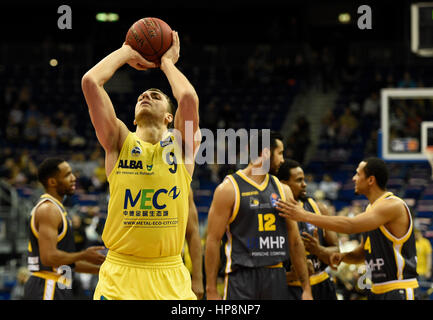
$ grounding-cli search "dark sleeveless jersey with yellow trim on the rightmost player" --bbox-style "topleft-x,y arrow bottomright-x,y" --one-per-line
363,192 -> 418,294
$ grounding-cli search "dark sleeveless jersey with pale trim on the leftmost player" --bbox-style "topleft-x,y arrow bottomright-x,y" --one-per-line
27,193 -> 75,272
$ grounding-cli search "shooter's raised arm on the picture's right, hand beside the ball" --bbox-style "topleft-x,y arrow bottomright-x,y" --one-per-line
161,31 -> 200,165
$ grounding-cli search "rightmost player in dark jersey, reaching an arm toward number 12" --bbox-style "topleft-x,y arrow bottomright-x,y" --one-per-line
278,158 -> 418,300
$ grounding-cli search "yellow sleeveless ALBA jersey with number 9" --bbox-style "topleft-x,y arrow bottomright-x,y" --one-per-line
102,132 -> 191,258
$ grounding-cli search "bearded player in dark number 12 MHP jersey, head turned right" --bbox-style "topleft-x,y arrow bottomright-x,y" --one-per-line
205,133 -> 312,300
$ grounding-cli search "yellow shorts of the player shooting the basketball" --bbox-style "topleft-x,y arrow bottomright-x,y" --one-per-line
93,251 -> 197,300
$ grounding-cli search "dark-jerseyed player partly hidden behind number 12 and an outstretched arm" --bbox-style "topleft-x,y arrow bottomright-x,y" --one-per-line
277,159 -> 339,300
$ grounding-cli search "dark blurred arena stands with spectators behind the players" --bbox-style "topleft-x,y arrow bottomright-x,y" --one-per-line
0,1 -> 433,299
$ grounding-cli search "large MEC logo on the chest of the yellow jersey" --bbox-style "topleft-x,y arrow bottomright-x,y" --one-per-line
123,186 -> 180,210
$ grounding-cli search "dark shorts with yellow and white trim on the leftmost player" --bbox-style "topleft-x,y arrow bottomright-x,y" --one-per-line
23,272 -> 73,300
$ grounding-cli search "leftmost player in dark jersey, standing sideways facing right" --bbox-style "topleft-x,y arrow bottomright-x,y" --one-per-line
24,158 -> 105,300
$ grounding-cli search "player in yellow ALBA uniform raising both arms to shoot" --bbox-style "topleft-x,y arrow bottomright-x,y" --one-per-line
82,27 -> 200,300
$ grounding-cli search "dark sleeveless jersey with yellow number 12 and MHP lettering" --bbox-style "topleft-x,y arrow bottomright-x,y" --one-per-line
225,171 -> 288,273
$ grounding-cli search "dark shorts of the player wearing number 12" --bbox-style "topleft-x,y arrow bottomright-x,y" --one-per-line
224,263 -> 288,300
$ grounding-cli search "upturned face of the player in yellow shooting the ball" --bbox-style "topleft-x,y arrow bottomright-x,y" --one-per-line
135,90 -> 170,126
